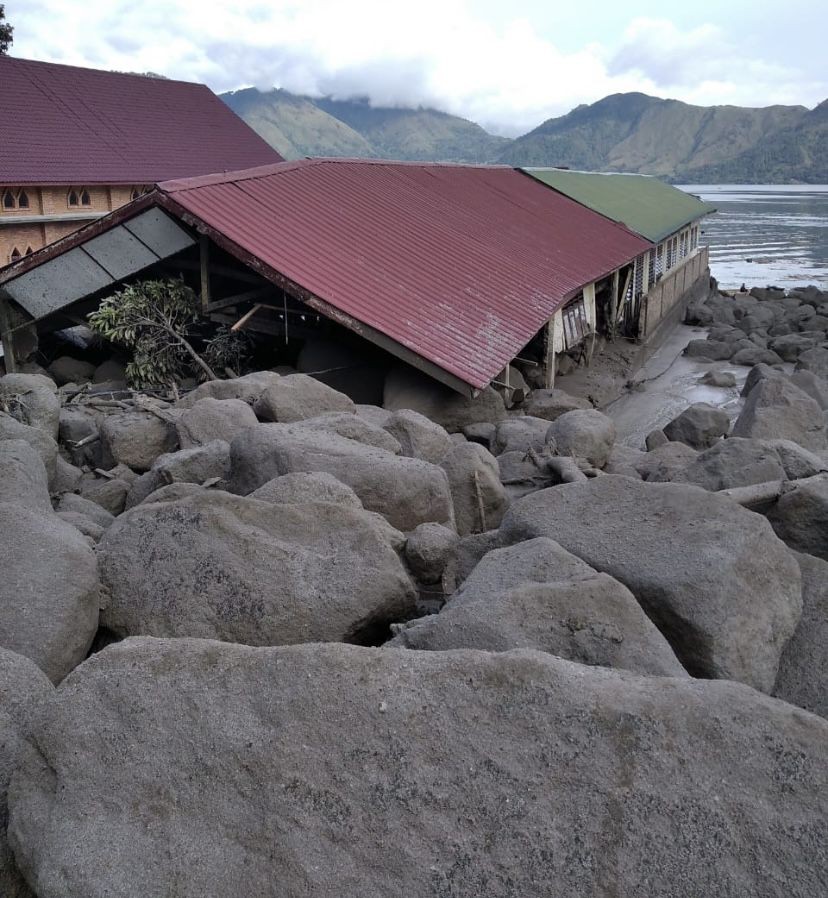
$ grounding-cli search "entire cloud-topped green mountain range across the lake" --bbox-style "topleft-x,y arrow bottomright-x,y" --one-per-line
222,88 -> 828,183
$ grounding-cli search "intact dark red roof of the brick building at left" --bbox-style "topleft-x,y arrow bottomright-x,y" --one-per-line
0,56 -> 281,185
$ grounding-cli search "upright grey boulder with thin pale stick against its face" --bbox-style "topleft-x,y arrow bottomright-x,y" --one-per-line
438,443 -> 509,536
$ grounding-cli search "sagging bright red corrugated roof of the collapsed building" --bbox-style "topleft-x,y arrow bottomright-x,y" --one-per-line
159,159 -> 651,388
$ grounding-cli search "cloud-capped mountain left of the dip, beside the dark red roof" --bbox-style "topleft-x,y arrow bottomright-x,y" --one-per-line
221,88 -> 510,162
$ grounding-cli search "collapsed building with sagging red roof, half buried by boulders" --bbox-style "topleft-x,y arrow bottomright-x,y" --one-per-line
0,159 -> 710,401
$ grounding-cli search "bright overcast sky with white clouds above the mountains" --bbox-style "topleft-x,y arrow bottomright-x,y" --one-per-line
8,0 -> 828,135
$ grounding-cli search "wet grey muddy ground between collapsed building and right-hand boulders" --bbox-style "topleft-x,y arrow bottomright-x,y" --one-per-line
603,324 -> 750,449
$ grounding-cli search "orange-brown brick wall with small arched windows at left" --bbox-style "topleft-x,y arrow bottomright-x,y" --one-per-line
0,184 -> 145,267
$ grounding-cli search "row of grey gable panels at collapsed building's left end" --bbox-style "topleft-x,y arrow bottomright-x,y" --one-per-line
3,209 -> 195,320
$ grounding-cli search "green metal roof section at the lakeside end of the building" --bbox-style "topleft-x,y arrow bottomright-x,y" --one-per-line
522,168 -> 716,243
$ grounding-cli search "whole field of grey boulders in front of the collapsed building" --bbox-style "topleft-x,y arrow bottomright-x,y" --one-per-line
0,288 -> 828,898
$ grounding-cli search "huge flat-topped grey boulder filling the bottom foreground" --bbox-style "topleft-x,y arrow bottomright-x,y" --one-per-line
9,639 -> 828,898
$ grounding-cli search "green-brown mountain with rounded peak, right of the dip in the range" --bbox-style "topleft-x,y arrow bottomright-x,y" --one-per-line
500,93 -> 808,181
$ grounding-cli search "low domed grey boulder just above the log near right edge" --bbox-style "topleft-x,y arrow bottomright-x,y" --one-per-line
670,437 -> 786,492
